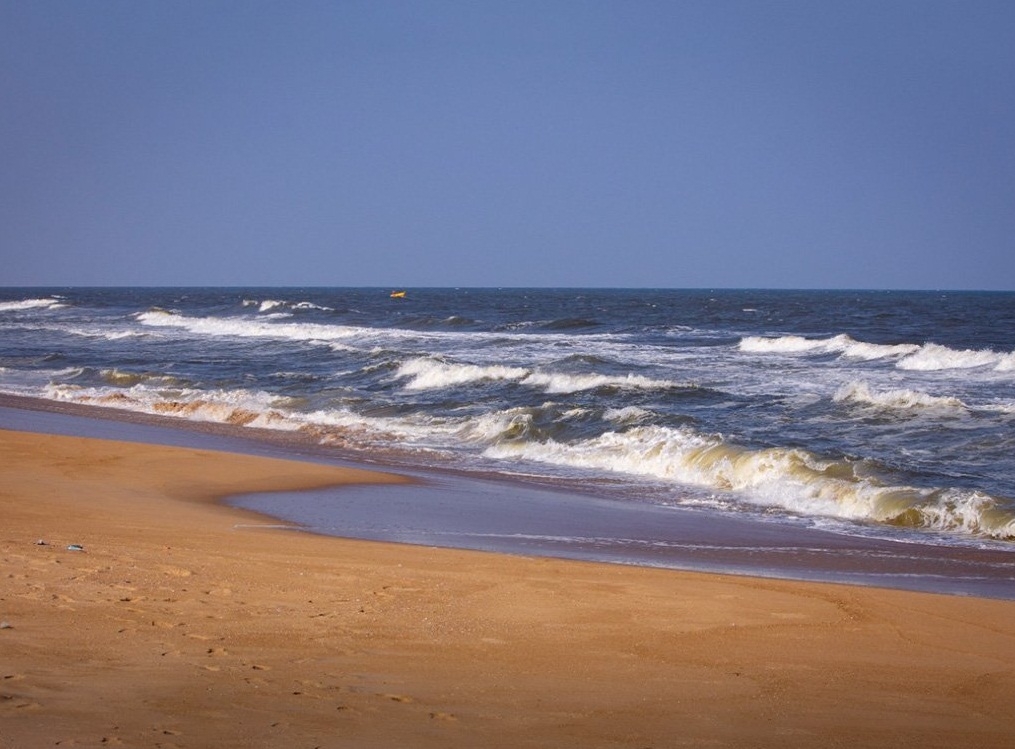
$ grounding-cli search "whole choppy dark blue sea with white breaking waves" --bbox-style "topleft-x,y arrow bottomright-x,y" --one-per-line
0,288 -> 1015,547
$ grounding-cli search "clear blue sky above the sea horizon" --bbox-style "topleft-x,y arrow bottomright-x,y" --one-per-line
0,0 -> 1015,290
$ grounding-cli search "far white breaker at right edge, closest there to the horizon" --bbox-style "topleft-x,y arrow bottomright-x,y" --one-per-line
738,333 -> 1015,371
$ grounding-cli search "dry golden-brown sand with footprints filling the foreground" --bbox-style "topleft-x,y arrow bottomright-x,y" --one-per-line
0,431 -> 1015,749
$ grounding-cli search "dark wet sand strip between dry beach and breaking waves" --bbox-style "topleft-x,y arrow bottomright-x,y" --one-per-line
0,396 -> 1015,600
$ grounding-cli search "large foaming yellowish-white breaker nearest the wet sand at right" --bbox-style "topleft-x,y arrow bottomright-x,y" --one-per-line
485,425 -> 1015,539
